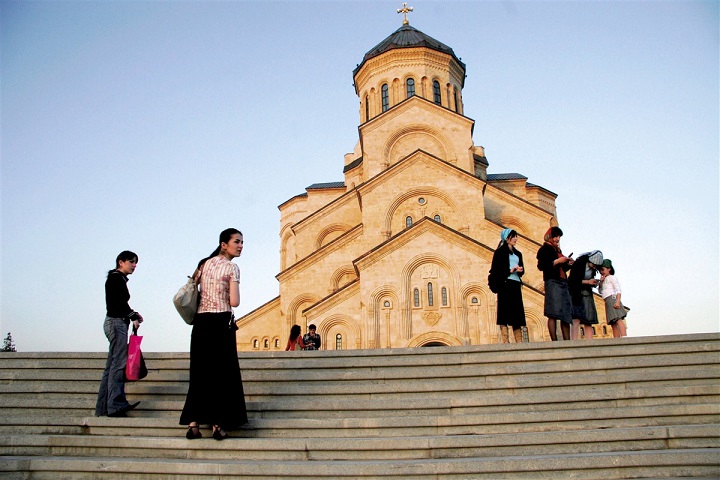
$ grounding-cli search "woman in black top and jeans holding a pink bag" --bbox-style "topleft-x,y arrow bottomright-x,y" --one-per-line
95,250 -> 143,417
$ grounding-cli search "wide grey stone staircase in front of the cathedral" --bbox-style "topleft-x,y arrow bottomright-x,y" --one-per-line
0,334 -> 720,480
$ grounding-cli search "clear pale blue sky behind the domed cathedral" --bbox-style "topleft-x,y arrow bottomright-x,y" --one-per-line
0,0 -> 720,352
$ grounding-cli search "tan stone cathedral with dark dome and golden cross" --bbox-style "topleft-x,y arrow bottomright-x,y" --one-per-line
237,9 -> 612,351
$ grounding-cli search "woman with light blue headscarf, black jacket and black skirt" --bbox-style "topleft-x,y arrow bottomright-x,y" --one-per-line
489,228 -> 525,343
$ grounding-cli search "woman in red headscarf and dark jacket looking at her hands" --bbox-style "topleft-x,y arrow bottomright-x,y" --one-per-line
536,227 -> 574,341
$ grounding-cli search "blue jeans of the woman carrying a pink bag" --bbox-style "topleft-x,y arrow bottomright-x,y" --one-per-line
95,317 -> 130,417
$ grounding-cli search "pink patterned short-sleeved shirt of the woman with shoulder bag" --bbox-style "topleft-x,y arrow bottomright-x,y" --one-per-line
198,255 -> 240,313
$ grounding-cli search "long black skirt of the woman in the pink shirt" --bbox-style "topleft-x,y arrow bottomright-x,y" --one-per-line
180,312 -> 248,430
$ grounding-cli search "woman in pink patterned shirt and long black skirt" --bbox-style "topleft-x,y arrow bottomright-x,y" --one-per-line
180,228 -> 248,440
